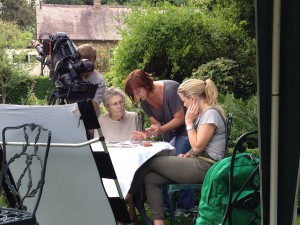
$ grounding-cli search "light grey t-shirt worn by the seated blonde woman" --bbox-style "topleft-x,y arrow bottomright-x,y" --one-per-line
195,108 -> 226,161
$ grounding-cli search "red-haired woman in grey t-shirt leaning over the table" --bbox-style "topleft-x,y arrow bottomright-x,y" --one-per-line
125,69 -> 195,215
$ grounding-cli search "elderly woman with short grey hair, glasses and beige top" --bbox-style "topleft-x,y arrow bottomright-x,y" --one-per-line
95,88 -> 140,142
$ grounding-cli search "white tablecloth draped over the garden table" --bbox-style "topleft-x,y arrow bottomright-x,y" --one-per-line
91,141 -> 174,197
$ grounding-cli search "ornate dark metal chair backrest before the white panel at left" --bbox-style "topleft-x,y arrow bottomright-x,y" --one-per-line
1,123 -> 51,216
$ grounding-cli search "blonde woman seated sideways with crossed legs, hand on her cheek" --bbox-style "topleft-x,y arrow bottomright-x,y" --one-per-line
127,79 -> 226,225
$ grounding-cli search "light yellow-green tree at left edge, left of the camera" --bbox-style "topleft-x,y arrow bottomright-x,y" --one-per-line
0,20 -> 32,103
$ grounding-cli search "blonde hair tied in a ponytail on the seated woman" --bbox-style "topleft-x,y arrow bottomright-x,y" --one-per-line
178,79 -> 224,116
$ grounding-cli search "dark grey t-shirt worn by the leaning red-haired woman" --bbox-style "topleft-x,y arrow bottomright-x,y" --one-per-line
141,80 -> 187,142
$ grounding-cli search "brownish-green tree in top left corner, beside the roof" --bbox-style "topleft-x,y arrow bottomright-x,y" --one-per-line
0,0 -> 35,28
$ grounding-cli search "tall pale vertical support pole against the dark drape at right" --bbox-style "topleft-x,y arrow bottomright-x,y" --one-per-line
270,0 -> 281,225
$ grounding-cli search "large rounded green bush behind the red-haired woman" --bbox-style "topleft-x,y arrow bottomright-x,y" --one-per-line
106,2 -> 255,95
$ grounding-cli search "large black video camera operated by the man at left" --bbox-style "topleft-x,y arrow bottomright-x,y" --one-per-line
32,32 -> 96,104
